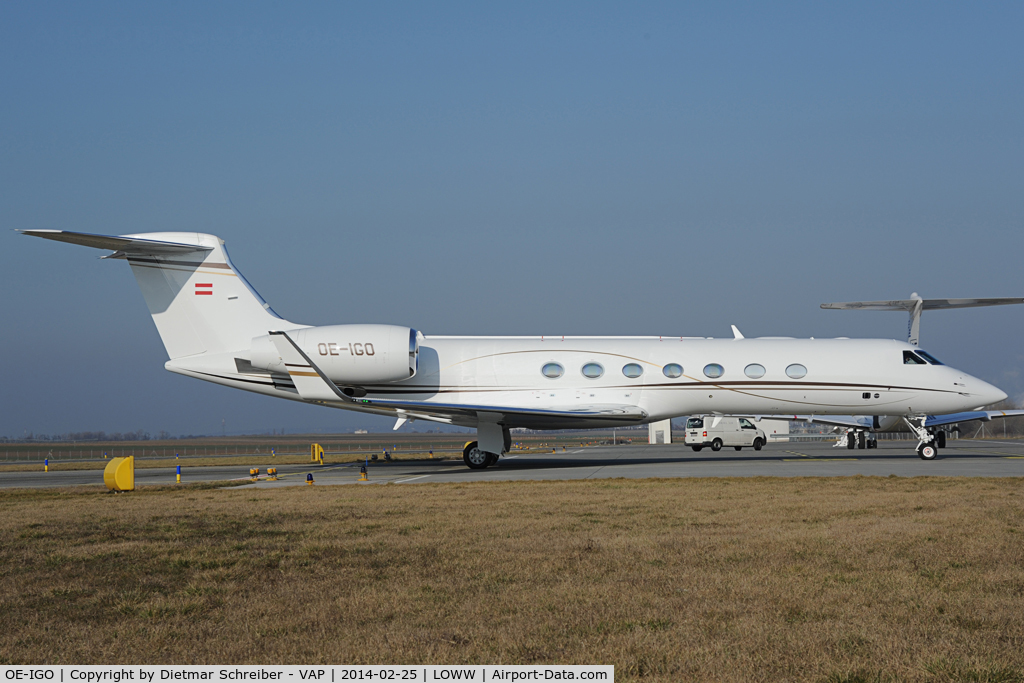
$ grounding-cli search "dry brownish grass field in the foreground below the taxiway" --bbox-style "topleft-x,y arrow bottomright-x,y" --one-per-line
0,477 -> 1024,681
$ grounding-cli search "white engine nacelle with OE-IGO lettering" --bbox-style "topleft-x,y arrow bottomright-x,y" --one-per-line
249,325 -> 420,387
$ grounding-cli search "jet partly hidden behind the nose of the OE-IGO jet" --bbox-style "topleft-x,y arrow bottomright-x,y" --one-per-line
774,292 -> 1024,449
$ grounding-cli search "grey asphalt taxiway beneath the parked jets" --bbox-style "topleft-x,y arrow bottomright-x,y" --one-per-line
0,439 -> 1024,488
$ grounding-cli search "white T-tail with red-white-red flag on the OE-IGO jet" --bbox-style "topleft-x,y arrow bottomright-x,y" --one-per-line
19,230 -> 296,359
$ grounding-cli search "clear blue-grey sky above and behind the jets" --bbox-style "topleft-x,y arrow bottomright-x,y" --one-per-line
0,2 -> 1024,436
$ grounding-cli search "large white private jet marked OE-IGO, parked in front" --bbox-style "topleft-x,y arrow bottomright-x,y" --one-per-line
23,230 -> 1006,468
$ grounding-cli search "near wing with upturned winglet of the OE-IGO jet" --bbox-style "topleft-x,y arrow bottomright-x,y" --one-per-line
269,332 -> 647,428
